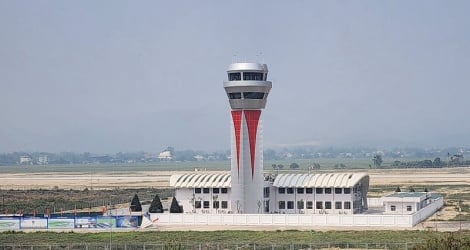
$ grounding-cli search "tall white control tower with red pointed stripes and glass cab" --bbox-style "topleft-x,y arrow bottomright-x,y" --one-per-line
224,63 -> 272,214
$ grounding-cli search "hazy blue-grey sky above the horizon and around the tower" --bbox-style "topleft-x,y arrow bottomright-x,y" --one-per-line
0,0 -> 470,153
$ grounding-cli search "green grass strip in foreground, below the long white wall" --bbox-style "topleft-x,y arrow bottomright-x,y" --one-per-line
0,230 -> 470,244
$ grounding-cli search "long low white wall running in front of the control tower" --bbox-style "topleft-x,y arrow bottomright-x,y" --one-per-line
150,198 -> 444,228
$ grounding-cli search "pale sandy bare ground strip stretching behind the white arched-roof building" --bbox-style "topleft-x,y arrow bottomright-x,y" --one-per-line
0,168 -> 470,189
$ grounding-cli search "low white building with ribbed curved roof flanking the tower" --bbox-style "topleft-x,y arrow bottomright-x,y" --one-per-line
170,173 -> 369,214
